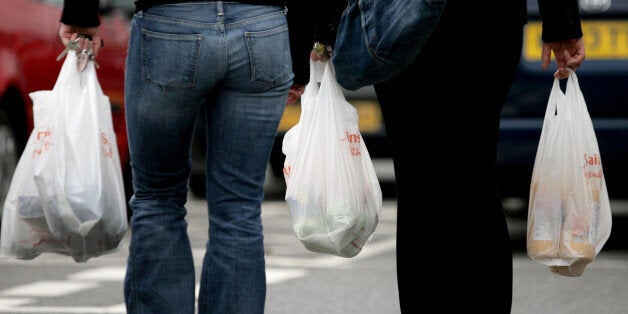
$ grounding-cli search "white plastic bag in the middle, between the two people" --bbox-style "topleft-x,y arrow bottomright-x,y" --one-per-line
282,61 -> 382,257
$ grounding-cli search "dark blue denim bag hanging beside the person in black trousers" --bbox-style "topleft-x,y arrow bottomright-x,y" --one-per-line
332,0 -> 445,90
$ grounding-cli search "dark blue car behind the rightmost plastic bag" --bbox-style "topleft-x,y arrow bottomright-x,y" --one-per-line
497,0 -> 628,212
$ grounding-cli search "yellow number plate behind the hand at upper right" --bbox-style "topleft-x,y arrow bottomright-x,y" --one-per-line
523,20 -> 628,62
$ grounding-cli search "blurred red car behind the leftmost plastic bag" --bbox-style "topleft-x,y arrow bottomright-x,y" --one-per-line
0,0 -> 132,221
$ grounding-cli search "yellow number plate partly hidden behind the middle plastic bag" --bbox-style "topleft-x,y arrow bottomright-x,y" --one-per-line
279,99 -> 382,133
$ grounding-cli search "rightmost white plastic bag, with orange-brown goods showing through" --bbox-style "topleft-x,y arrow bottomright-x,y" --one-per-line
527,71 -> 612,277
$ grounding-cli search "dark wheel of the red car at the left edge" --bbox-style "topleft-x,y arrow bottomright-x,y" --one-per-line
0,110 -> 19,226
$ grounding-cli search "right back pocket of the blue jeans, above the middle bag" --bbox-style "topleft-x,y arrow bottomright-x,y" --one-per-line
244,24 -> 292,86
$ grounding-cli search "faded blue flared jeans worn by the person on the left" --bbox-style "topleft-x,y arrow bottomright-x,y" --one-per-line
124,1 -> 293,314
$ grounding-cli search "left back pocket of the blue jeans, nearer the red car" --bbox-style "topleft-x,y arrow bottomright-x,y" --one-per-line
142,29 -> 203,90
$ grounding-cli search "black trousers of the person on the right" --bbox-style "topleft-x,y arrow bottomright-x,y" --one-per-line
375,0 -> 528,313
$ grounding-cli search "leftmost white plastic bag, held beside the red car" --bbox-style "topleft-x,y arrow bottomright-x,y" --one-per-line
0,51 -> 128,262
